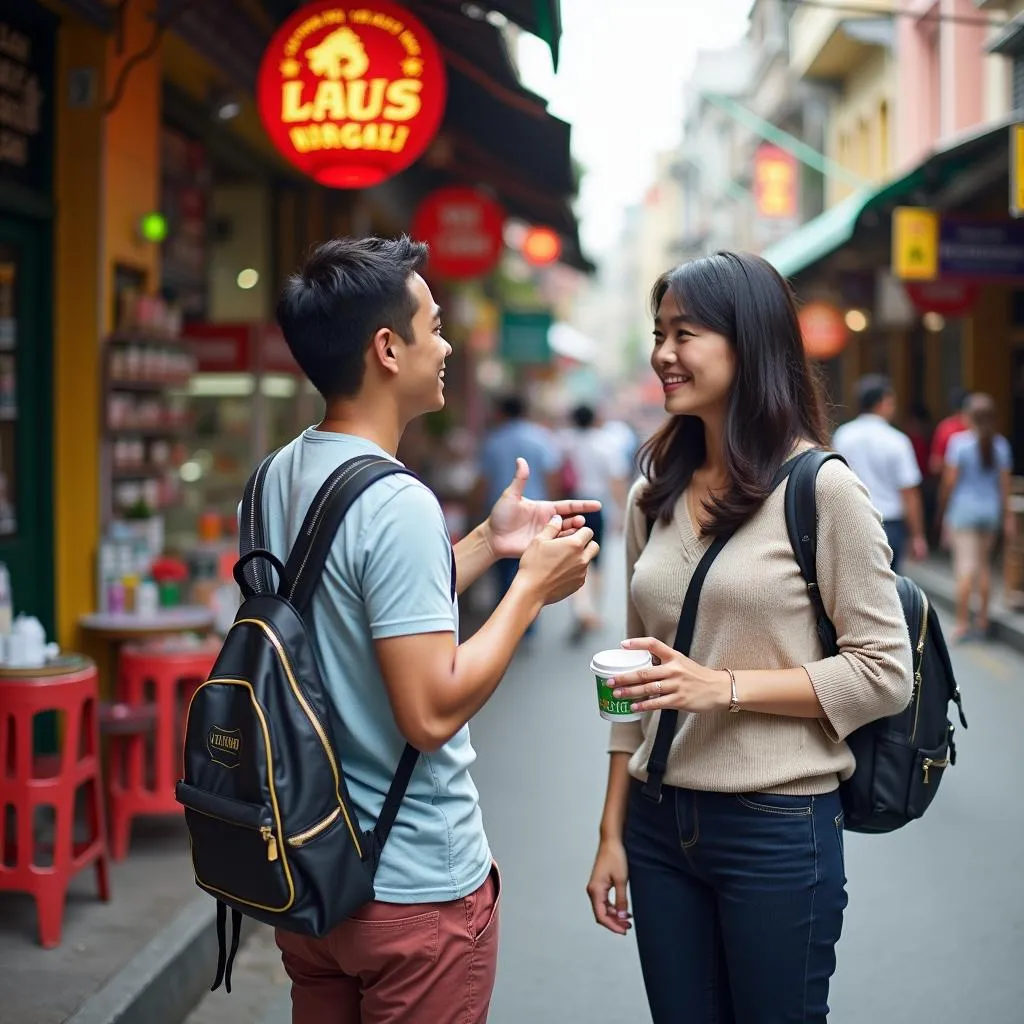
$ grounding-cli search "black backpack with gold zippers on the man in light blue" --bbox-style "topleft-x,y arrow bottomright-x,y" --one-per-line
176,455 -> 432,991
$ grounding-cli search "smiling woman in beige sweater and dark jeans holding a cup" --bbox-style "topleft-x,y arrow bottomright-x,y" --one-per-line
588,253 -> 911,1024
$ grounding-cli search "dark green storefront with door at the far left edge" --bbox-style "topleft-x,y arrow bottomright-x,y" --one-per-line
0,0 -> 58,629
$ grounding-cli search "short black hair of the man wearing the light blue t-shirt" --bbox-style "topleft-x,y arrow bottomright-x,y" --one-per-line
278,234 -> 427,399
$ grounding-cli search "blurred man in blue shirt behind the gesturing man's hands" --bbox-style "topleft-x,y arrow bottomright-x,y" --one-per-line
475,394 -> 560,598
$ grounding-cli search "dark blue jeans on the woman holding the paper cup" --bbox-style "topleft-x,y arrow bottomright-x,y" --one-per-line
625,782 -> 847,1024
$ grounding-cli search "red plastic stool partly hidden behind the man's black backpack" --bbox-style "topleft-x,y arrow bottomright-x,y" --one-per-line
108,644 -> 220,860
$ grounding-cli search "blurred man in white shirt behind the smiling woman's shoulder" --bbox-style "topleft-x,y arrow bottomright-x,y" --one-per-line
833,376 -> 928,570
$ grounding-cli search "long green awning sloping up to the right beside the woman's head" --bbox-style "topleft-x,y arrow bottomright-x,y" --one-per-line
761,120 -> 1015,278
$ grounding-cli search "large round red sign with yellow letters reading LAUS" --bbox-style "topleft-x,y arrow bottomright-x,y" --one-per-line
257,0 -> 446,188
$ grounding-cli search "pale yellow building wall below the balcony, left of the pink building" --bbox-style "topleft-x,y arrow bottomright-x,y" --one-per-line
825,50 -> 896,206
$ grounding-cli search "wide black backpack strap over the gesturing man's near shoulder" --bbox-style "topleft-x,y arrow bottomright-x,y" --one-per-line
281,455 -> 416,617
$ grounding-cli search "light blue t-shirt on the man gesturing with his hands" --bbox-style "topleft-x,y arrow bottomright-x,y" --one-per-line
263,428 -> 492,903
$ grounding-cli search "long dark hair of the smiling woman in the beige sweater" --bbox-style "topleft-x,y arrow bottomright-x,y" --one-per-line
639,252 -> 828,537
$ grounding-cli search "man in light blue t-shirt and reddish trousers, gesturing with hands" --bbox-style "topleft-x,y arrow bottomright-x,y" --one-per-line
263,238 -> 598,1024
